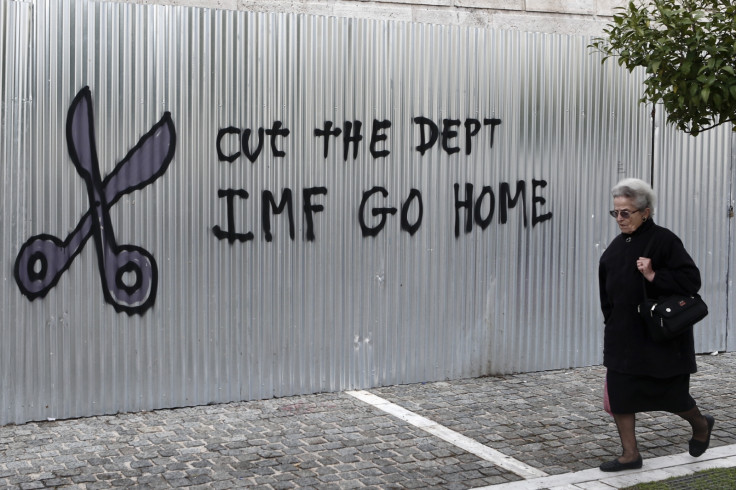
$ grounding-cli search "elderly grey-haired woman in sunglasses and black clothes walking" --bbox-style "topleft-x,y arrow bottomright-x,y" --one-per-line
598,179 -> 714,471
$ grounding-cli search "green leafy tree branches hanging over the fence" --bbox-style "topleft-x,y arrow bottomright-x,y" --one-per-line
591,0 -> 736,135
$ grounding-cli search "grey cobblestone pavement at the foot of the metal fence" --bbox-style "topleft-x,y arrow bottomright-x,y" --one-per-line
0,353 -> 736,489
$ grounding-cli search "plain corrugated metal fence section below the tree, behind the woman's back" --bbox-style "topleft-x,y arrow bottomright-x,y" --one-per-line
654,108 -> 736,353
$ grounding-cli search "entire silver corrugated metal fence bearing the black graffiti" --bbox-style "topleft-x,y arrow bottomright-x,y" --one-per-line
0,0 -> 734,425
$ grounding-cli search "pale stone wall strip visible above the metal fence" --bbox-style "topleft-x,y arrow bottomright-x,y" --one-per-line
108,0 -> 626,35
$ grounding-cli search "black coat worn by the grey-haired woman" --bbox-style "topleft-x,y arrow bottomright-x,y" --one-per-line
598,220 -> 700,378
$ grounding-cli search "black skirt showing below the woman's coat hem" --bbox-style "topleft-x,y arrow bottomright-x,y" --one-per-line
606,369 -> 695,413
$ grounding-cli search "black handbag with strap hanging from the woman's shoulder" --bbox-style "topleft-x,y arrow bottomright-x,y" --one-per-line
638,229 -> 708,342
